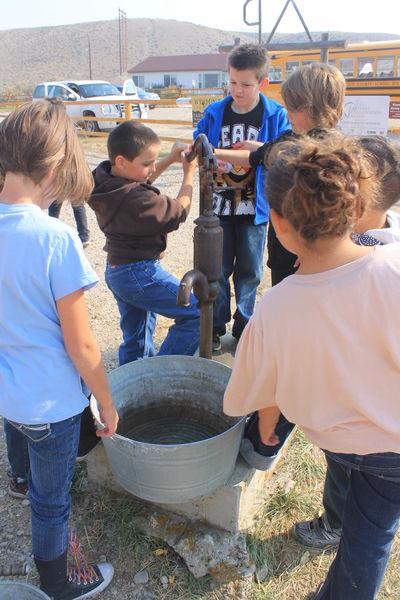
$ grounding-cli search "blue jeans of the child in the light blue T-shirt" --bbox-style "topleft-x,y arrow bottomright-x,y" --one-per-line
9,414 -> 81,560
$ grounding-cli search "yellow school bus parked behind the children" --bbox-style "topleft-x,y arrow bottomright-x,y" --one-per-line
263,40 -> 400,133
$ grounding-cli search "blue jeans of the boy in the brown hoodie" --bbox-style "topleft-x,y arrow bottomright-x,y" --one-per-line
105,260 -> 200,365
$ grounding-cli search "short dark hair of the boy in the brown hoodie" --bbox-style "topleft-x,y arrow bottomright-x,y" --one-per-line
107,121 -> 160,165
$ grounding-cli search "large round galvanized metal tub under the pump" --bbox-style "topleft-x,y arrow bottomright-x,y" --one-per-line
92,356 -> 245,504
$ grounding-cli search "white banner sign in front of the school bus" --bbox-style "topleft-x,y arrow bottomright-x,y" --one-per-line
337,96 -> 390,135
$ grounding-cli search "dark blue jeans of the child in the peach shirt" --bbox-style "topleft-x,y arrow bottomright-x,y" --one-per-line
316,451 -> 400,600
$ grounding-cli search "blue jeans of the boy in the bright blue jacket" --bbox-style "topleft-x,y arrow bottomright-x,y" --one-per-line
213,219 -> 267,338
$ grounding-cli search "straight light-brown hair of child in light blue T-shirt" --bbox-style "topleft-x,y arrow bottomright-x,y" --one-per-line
0,100 -> 93,204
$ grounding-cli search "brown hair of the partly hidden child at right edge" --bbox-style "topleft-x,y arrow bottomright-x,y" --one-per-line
358,135 -> 400,212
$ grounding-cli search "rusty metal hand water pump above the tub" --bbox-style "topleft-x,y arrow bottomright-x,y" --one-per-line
177,133 -> 223,358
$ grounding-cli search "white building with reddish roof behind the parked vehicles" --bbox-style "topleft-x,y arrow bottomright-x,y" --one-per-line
128,54 -> 228,89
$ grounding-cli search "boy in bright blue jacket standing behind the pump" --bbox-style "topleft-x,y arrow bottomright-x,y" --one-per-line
194,44 -> 290,351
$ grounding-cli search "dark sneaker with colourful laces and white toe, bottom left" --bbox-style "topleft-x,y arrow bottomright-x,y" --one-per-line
54,531 -> 114,600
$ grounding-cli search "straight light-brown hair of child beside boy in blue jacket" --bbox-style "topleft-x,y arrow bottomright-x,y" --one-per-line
281,63 -> 346,127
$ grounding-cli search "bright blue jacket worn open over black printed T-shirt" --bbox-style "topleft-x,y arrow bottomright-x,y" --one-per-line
193,94 -> 290,225
